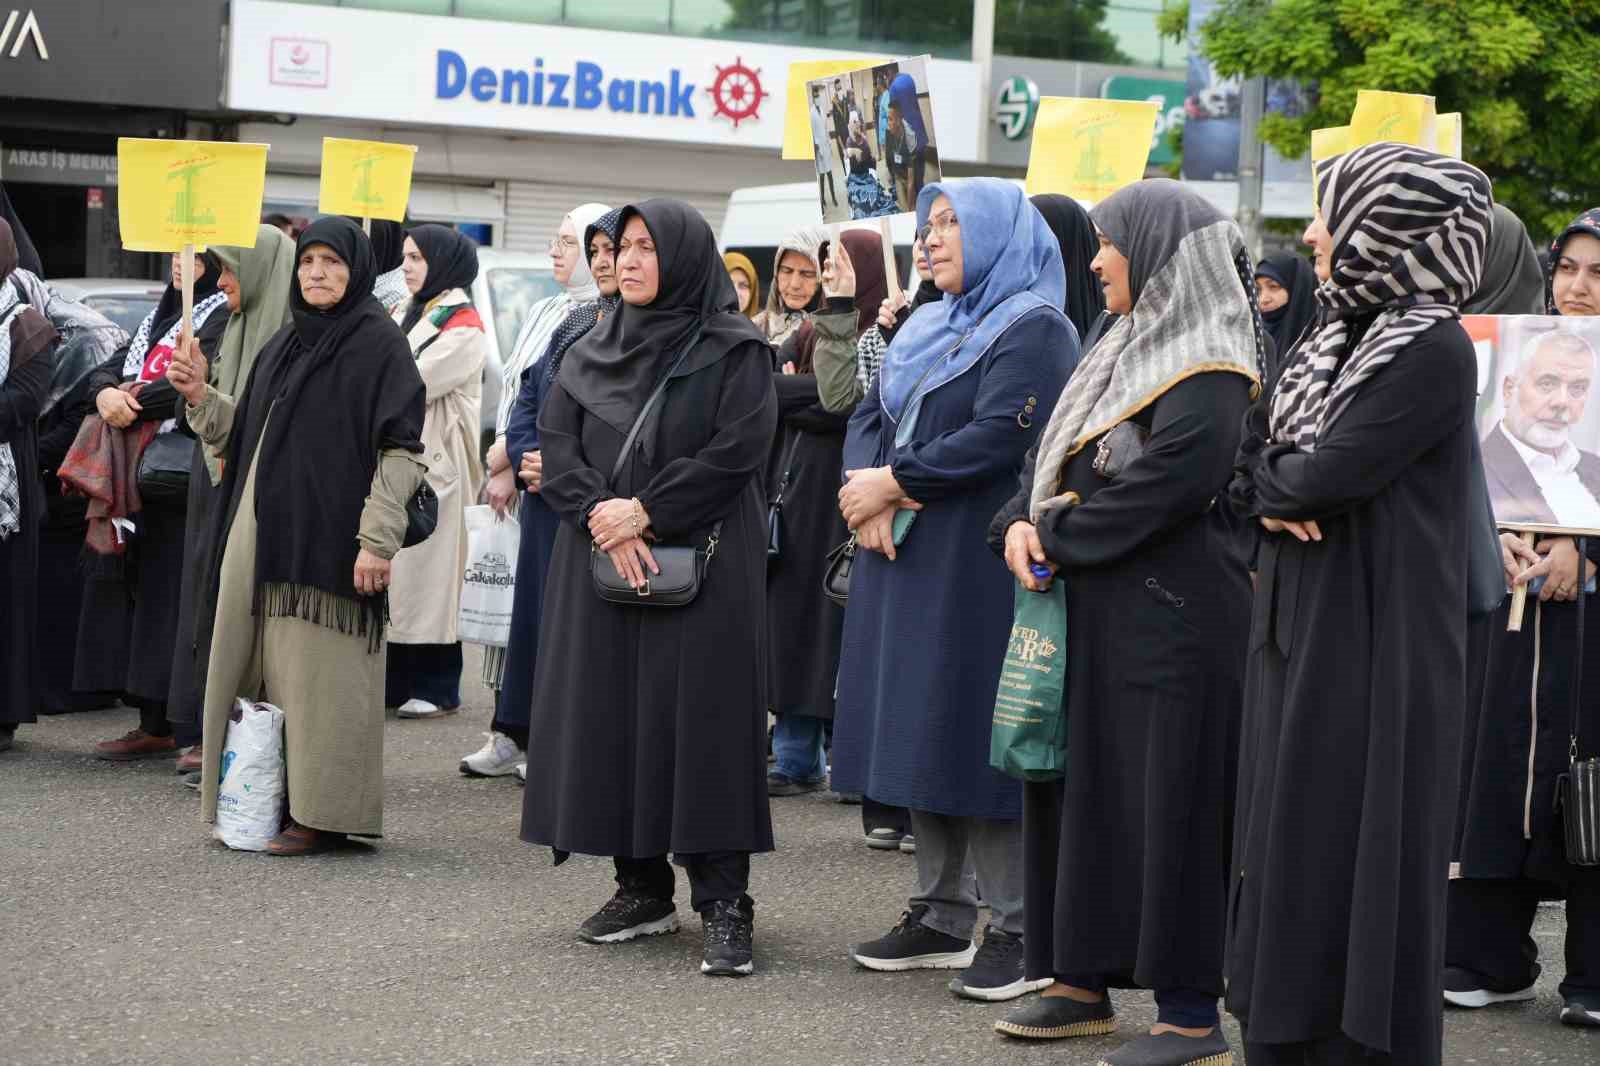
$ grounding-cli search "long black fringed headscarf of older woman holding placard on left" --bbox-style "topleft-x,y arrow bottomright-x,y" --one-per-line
211,216 -> 426,648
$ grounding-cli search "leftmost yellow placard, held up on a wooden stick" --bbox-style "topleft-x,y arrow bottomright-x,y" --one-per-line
117,138 -> 267,251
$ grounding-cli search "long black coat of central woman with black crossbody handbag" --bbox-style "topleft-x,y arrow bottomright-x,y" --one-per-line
522,339 -> 778,858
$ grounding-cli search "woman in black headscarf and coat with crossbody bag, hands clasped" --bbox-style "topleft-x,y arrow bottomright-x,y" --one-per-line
522,200 -> 778,975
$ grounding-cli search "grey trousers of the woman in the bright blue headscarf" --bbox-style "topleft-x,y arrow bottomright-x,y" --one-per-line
910,810 -> 1022,940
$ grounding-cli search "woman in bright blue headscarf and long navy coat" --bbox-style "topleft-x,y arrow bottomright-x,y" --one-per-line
834,178 -> 1078,1000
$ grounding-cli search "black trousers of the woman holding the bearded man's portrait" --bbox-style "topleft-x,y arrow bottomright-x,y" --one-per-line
1445,868 -> 1600,1008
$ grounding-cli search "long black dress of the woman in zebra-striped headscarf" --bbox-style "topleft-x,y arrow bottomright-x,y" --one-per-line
1227,319 -> 1477,1066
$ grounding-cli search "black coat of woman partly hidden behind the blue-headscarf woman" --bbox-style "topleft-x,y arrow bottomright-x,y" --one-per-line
766,375 -> 850,720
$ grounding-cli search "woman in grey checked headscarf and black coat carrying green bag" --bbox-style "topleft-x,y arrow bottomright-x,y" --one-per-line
990,181 -> 1264,1066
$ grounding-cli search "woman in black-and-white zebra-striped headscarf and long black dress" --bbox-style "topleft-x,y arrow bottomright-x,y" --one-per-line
1227,142 -> 1493,1066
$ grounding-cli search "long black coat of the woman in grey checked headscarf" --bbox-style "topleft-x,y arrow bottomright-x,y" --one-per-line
990,373 -> 1250,996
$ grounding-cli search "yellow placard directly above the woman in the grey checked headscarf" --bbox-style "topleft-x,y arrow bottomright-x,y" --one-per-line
1027,96 -> 1160,202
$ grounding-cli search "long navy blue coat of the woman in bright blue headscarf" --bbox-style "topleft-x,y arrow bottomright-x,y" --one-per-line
834,312 -> 1078,818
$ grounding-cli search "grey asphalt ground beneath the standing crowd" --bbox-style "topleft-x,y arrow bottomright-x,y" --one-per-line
0,646 -> 1600,1066
